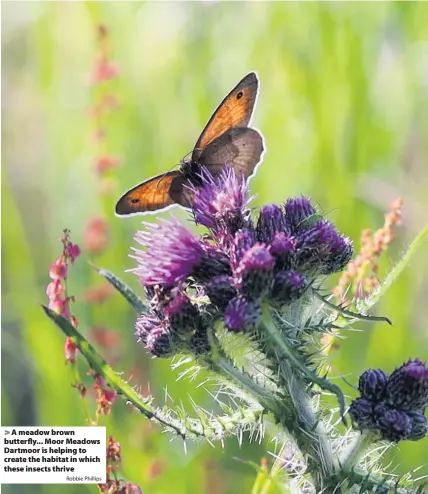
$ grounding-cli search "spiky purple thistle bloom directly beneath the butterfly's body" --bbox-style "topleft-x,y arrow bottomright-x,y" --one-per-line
189,166 -> 252,234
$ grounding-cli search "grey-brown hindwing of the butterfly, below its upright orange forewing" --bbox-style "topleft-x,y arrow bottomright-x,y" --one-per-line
199,127 -> 264,178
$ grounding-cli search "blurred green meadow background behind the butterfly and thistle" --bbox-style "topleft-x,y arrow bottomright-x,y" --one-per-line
1,2 -> 428,494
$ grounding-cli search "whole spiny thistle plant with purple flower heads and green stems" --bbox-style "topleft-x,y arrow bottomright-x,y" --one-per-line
47,166 -> 428,493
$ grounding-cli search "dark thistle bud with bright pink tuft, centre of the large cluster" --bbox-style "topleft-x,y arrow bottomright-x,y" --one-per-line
234,244 -> 275,299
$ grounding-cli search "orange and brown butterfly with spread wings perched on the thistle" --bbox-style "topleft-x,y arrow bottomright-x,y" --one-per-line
116,72 -> 265,216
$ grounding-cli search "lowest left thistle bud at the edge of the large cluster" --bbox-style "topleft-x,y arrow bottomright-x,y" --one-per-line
135,314 -> 172,357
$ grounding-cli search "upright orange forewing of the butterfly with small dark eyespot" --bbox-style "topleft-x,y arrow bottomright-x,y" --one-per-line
192,72 -> 259,161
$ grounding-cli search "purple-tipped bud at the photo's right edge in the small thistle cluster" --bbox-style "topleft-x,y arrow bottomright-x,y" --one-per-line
386,359 -> 428,411
